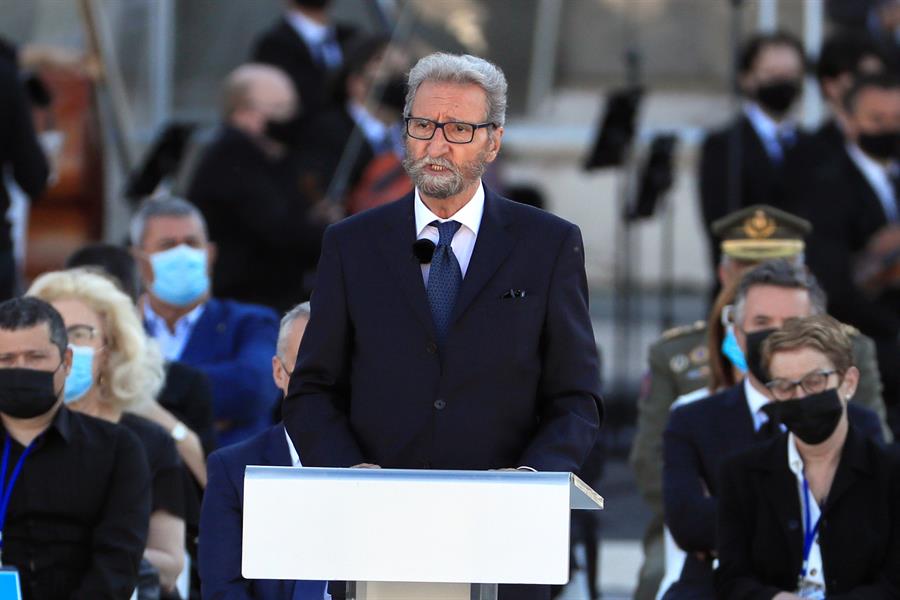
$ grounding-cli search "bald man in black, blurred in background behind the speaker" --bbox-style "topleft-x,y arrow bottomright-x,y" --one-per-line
187,64 -> 335,311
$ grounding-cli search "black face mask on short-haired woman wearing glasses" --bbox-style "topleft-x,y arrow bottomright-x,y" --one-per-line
762,388 -> 844,446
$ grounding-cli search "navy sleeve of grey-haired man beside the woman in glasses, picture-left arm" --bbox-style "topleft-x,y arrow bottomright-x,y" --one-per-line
663,406 -> 716,552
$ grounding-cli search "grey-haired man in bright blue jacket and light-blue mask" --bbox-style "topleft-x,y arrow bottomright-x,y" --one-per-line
130,197 -> 278,446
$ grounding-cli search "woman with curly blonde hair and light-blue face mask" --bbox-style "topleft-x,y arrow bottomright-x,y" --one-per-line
28,269 -> 185,591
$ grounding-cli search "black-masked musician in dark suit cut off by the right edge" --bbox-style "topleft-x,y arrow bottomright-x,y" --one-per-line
791,75 -> 900,431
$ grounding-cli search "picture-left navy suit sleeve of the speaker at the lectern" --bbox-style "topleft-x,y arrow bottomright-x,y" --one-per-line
282,227 -> 366,467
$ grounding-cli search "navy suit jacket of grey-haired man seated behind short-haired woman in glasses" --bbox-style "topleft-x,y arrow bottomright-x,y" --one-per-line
663,382 -> 883,598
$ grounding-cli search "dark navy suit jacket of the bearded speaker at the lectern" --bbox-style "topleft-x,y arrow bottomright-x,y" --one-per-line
284,190 -> 601,471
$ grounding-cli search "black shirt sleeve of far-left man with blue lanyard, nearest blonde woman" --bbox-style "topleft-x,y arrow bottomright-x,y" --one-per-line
71,427 -> 151,600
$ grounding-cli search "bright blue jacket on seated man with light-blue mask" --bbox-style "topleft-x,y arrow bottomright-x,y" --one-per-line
165,298 -> 279,446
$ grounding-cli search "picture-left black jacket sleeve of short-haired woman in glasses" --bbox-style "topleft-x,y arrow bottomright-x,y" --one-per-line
715,457 -> 782,600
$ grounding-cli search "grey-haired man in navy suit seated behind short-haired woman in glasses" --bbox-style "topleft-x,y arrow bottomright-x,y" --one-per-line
663,260 -> 883,600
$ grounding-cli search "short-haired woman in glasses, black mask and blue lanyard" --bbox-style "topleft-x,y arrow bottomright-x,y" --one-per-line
716,315 -> 900,600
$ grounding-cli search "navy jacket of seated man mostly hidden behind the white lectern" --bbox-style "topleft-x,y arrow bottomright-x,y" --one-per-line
199,423 -> 325,600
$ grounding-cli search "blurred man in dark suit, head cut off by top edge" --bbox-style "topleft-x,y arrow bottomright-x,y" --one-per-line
251,0 -> 356,144
